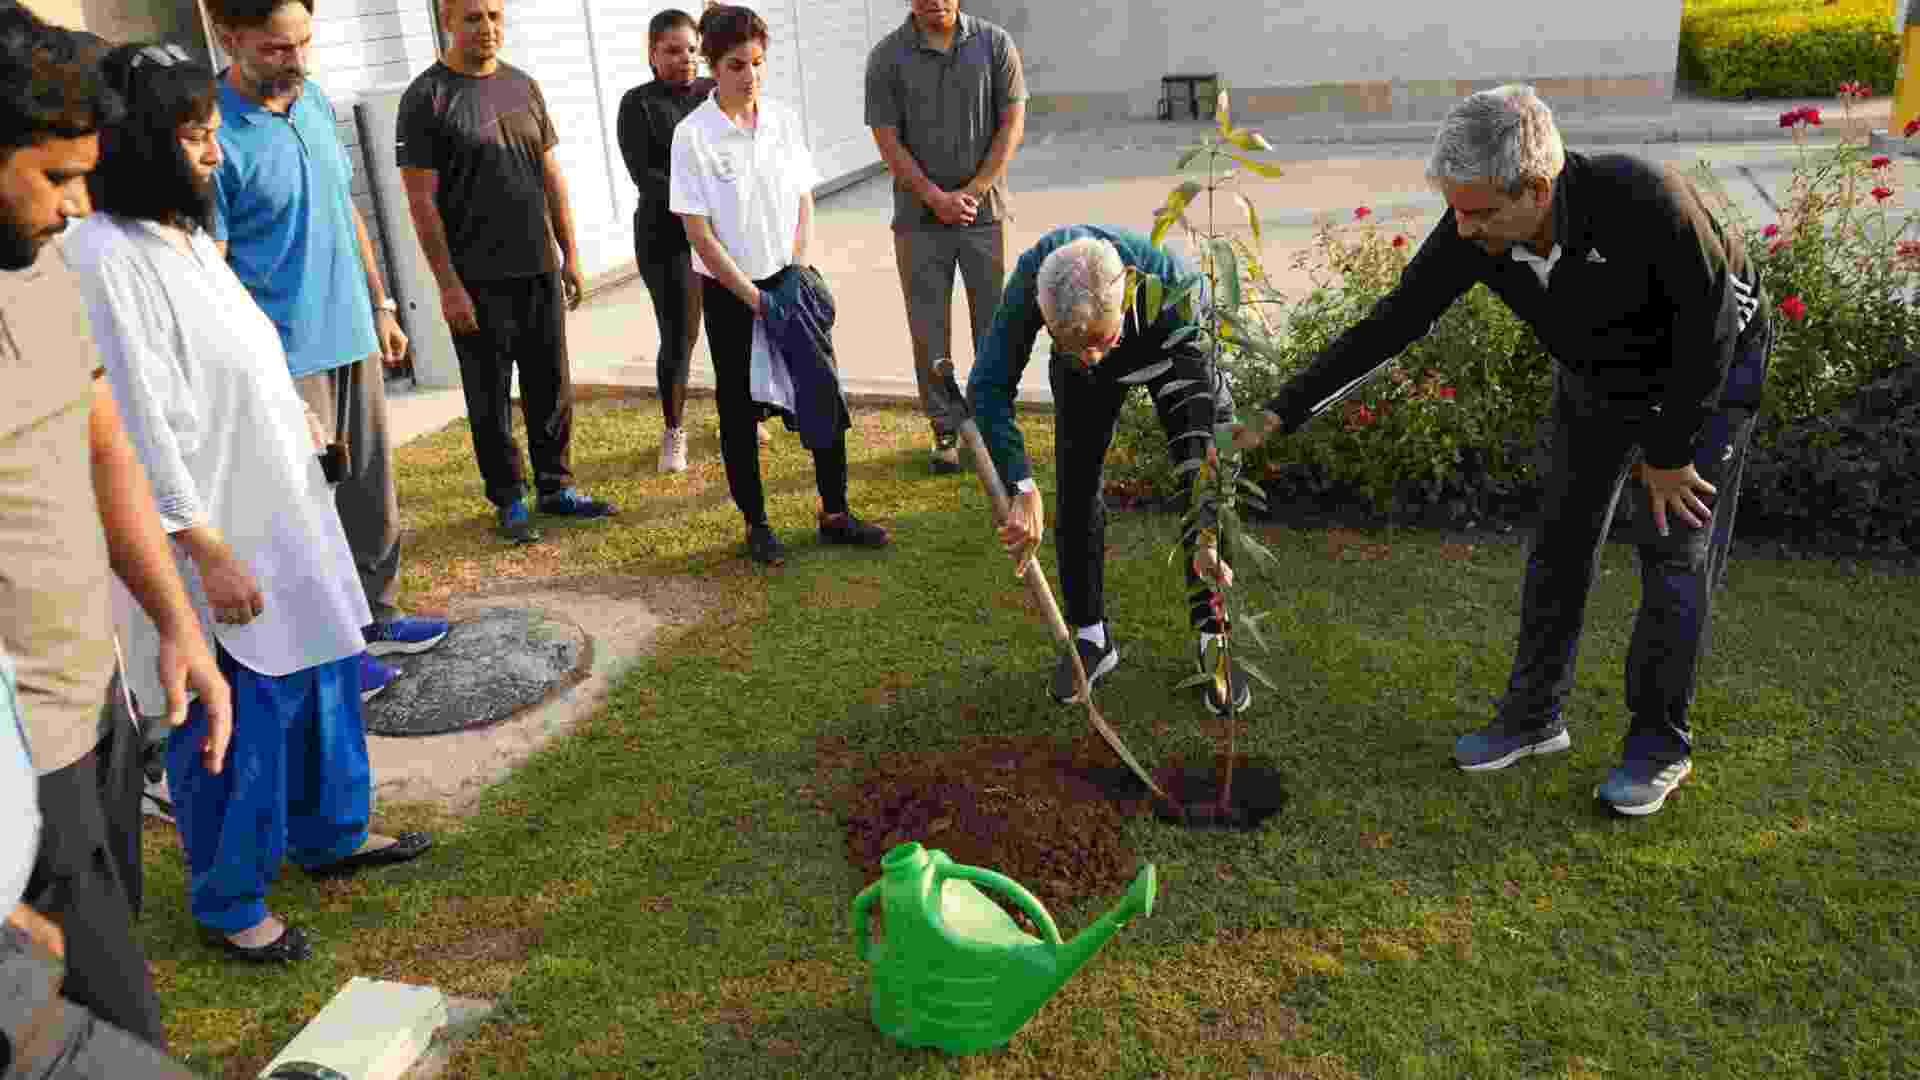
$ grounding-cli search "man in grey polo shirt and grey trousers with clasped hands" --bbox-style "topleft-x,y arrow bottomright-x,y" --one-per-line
866,0 -> 1027,473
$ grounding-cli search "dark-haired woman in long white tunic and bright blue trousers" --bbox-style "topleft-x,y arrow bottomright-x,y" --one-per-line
65,46 -> 428,961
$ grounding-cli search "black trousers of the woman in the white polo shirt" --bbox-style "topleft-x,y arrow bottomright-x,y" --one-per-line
701,269 -> 847,528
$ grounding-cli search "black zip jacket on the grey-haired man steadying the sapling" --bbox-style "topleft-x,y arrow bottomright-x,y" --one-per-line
1267,152 -> 1764,469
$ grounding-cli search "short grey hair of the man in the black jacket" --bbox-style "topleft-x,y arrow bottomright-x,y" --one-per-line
1427,83 -> 1567,196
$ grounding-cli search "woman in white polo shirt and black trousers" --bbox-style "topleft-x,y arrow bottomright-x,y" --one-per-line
668,6 -> 889,565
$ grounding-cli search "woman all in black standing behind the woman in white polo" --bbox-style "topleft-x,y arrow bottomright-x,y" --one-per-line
616,10 -> 714,473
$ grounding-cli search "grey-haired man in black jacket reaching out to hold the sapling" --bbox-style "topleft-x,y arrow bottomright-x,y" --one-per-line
1240,86 -> 1772,815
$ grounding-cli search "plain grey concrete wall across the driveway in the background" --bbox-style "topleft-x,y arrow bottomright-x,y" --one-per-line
962,0 -> 1682,119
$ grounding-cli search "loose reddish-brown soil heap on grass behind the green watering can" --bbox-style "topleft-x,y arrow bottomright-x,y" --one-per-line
822,736 -> 1146,909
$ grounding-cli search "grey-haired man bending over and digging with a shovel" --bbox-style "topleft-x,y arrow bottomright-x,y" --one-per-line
968,225 -> 1252,713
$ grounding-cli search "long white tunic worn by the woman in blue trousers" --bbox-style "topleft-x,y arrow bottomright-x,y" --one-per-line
65,213 -> 372,715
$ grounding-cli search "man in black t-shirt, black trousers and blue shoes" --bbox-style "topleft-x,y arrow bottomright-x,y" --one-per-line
396,0 -> 614,544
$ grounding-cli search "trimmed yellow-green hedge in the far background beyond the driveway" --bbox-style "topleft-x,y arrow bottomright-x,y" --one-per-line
1680,0 -> 1901,98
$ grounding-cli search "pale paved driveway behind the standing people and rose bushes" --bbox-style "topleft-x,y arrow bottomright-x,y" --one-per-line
390,98 -> 1889,442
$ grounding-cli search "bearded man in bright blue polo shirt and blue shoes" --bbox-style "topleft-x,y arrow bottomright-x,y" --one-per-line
207,0 -> 447,664
